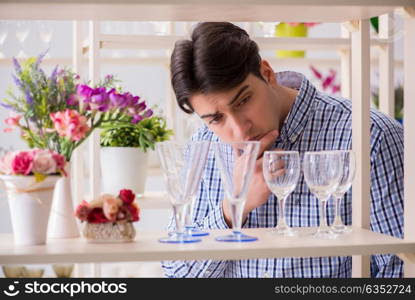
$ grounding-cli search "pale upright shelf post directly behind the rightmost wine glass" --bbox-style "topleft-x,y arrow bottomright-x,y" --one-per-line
351,20 -> 371,277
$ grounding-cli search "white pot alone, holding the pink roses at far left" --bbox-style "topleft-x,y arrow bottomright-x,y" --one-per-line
0,175 -> 61,245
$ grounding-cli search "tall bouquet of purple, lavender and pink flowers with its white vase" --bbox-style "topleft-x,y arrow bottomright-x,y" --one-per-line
0,53 -> 152,238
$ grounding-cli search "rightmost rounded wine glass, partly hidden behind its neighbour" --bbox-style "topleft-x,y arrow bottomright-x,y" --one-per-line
331,150 -> 356,233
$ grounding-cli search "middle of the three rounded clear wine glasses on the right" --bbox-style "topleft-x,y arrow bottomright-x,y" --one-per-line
303,151 -> 342,239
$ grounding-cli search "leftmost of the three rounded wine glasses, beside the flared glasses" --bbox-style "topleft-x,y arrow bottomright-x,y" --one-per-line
262,151 -> 301,236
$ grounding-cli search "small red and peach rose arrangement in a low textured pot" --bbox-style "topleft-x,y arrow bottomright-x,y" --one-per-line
75,189 -> 140,243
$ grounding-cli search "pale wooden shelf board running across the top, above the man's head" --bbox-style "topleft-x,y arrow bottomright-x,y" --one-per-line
0,0 -> 415,22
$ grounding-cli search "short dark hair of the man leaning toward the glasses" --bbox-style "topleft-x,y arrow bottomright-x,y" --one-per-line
170,22 -> 262,114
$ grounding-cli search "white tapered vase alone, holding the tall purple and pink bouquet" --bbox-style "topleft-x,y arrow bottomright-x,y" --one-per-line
48,163 -> 80,239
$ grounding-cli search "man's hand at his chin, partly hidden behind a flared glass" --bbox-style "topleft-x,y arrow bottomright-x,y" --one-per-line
222,130 -> 279,227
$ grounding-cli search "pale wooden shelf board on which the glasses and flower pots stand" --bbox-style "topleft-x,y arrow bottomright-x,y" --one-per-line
0,228 -> 415,264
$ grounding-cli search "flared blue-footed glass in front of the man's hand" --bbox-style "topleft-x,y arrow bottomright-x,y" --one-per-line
213,141 -> 260,242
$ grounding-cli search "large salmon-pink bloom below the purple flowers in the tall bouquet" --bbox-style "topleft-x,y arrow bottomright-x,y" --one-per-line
50,109 -> 90,141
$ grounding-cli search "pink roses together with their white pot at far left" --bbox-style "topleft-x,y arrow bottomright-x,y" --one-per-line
0,149 -> 66,245
